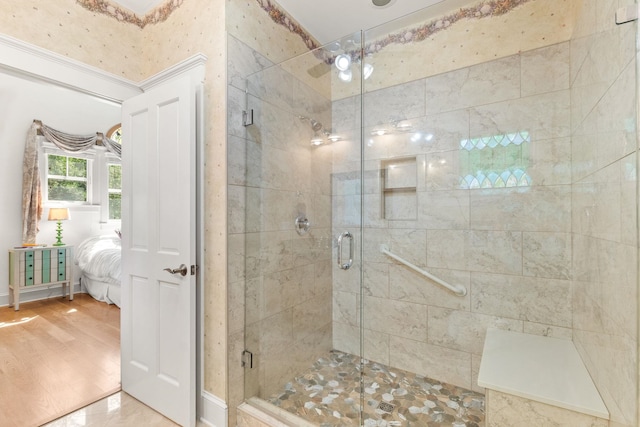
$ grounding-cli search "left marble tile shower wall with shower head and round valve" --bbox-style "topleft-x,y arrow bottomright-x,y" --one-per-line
227,35 -> 332,422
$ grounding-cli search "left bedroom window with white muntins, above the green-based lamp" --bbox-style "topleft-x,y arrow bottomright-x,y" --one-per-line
47,154 -> 89,203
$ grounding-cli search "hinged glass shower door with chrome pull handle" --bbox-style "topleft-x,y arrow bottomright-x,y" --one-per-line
236,33 -> 361,426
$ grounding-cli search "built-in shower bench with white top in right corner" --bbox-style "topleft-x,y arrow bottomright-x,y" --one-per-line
478,329 -> 609,427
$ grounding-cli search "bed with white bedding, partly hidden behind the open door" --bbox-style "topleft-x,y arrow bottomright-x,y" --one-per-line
75,235 -> 122,307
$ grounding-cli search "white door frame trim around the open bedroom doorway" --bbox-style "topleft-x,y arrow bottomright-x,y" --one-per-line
0,34 -> 216,426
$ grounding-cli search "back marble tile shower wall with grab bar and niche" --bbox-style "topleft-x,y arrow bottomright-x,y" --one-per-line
332,42 -> 573,390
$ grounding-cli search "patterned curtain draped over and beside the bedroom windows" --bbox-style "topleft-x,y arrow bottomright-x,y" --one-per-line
22,120 -> 122,243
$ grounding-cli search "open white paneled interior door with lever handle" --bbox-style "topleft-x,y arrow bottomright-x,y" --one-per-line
121,76 -> 196,426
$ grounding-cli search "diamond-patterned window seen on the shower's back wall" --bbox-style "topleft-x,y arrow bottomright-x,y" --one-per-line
459,131 -> 531,189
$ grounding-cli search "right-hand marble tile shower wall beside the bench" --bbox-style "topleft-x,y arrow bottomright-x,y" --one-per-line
570,0 -> 638,426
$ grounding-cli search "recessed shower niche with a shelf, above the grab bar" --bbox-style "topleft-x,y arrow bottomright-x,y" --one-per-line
380,157 -> 418,221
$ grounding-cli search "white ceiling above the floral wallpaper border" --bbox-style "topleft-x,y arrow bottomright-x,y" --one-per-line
114,0 -> 471,44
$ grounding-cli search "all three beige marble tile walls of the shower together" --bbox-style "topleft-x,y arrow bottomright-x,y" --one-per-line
227,0 -> 637,426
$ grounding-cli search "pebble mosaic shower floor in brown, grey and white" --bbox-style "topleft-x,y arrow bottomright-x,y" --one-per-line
268,351 -> 484,427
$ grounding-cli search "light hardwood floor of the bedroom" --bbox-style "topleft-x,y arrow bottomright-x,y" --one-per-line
0,294 -> 120,427
